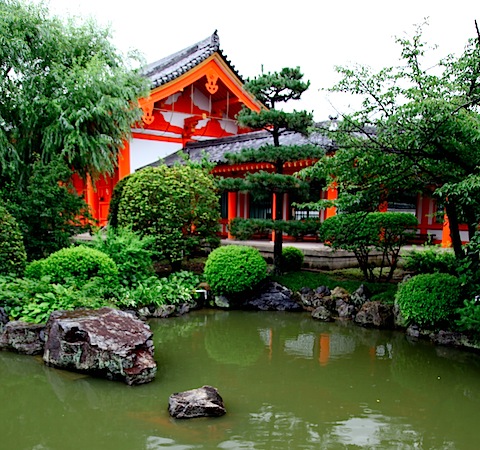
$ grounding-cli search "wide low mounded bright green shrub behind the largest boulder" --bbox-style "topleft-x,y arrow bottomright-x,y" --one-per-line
26,245 -> 118,284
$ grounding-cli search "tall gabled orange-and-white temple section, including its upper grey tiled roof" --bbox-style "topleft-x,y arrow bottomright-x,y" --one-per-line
74,32 -> 262,226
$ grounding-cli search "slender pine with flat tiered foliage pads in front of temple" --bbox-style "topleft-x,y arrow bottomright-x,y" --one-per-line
218,67 -> 324,272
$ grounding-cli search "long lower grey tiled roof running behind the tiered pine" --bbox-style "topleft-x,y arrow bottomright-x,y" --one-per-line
144,124 -> 334,166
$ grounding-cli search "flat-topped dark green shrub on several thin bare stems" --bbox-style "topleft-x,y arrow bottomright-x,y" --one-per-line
320,212 -> 418,281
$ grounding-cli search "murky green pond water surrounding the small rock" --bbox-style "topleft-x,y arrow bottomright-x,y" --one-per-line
0,310 -> 480,450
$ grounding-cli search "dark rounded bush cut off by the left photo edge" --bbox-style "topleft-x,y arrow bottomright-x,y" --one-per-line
0,206 -> 27,275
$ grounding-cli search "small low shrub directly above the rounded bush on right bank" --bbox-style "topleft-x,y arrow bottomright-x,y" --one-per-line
402,247 -> 458,275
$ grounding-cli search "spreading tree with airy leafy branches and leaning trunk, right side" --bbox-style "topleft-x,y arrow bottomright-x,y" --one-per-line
305,25 -> 480,257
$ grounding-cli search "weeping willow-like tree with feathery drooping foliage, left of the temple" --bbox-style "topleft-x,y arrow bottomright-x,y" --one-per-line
0,0 -> 148,258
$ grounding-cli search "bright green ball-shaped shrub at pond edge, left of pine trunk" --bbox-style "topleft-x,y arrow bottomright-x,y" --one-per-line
204,245 -> 267,295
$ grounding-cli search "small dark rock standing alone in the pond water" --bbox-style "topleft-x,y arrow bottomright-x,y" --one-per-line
168,386 -> 226,419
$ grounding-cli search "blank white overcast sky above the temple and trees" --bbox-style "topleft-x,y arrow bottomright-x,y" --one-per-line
34,0 -> 480,120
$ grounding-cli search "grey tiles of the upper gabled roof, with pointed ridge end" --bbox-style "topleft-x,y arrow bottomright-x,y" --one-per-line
142,30 -> 243,89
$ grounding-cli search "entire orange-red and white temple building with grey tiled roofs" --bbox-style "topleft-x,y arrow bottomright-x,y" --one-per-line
74,31 -> 468,250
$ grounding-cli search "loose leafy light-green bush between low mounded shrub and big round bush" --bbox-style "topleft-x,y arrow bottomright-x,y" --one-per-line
89,227 -> 155,287
